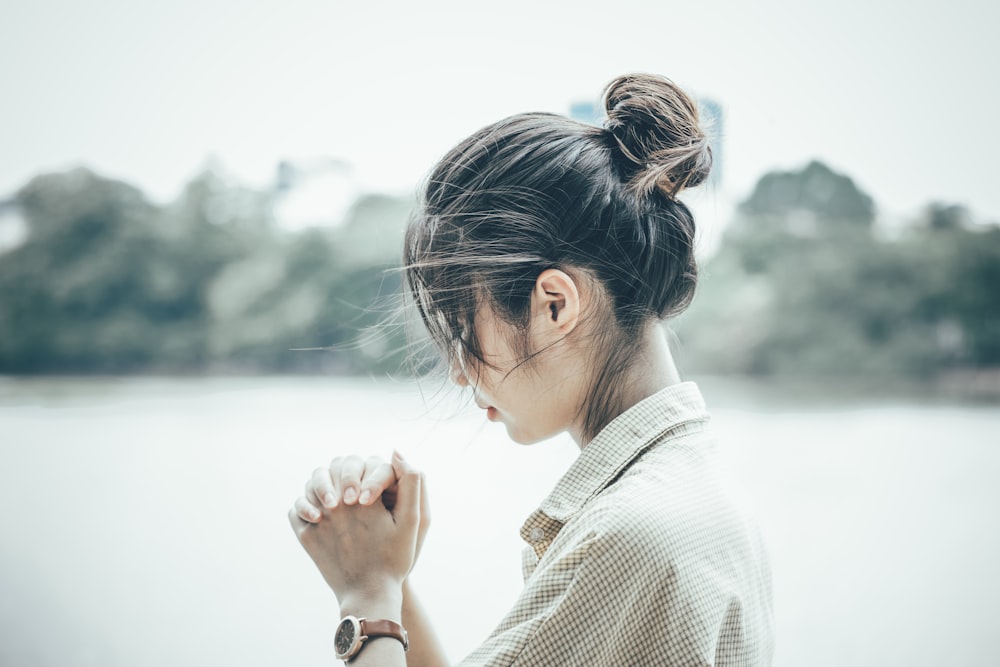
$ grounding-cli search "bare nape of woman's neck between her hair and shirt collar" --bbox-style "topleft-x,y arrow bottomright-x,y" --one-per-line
570,321 -> 681,449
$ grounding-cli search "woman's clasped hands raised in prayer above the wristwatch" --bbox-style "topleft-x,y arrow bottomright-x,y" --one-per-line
288,454 -> 430,604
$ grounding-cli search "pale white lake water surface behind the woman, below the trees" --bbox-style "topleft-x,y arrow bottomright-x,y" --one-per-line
0,378 -> 1000,667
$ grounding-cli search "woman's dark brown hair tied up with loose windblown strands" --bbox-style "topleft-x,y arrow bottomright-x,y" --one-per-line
404,75 -> 712,439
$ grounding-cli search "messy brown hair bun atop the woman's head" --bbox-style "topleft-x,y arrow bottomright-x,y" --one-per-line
604,74 -> 712,199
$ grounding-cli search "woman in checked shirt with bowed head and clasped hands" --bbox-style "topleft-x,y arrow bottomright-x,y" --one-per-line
289,75 -> 773,667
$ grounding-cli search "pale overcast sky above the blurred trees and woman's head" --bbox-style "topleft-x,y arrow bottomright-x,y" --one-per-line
0,0 -> 1000,220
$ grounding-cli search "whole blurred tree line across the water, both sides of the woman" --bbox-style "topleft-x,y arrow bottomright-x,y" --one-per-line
0,162 -> 1000,378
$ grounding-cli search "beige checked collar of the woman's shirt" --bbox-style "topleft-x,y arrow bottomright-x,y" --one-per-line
521,382 -> 709,551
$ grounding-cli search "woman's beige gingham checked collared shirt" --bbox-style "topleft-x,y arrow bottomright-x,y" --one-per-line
461,382 -> 774,667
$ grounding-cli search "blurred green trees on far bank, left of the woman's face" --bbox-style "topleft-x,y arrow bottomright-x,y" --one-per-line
0,169 -> 408,373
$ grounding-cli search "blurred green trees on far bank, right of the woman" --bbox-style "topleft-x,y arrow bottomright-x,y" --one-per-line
677,163 -> 1000,378
